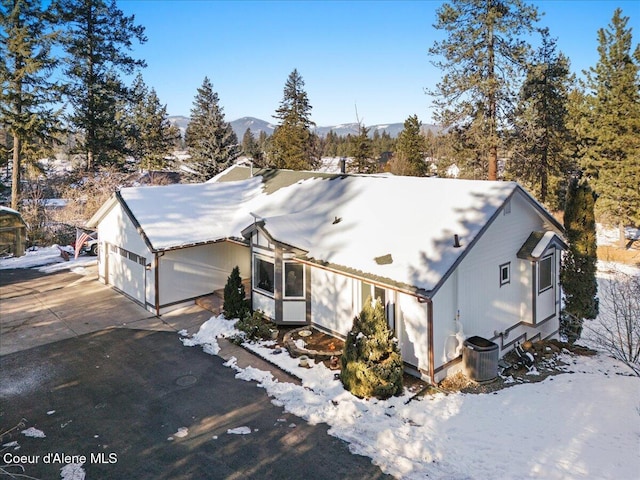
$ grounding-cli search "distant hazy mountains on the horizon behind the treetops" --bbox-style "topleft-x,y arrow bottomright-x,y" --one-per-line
169,115 -> 440,140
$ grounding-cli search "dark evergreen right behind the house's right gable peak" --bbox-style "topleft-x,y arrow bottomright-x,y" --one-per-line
507,29 -> 570,209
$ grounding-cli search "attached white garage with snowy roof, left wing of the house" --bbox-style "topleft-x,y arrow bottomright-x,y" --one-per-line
87,179 -> 262,315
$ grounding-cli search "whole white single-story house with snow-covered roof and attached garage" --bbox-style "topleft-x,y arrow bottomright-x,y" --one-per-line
90,166 -> 566,382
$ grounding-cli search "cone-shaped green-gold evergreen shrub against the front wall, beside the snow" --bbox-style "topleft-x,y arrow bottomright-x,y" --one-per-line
340,299 -> 403,399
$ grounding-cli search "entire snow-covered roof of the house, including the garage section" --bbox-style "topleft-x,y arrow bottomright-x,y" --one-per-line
93,167 -> 552,291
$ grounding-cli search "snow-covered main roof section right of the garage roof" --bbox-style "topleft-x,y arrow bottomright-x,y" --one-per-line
246,175 -> 519,291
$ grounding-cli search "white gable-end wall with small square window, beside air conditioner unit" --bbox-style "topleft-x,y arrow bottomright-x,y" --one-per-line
433,189 -> 557,369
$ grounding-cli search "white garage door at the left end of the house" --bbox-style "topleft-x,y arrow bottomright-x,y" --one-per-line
107,245 -> 147,306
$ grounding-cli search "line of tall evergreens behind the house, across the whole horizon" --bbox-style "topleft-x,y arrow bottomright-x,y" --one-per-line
0,0 -> 640,244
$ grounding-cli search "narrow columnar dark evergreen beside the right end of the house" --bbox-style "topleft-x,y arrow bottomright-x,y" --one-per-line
560,178 -> 598,343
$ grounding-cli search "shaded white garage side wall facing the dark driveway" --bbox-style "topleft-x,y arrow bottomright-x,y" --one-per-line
159,242 -> 250,305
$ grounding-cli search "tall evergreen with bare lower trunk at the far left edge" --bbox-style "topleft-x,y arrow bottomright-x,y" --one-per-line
0,0 -> 59,209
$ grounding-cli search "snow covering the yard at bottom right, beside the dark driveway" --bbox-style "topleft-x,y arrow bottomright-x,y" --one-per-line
186,317 -> 640,479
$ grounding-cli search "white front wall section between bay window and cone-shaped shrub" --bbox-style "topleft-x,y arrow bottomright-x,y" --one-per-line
311,268 -> 357,335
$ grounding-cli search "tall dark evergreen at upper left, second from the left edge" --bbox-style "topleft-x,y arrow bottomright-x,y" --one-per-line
55,0 -> 146,170
